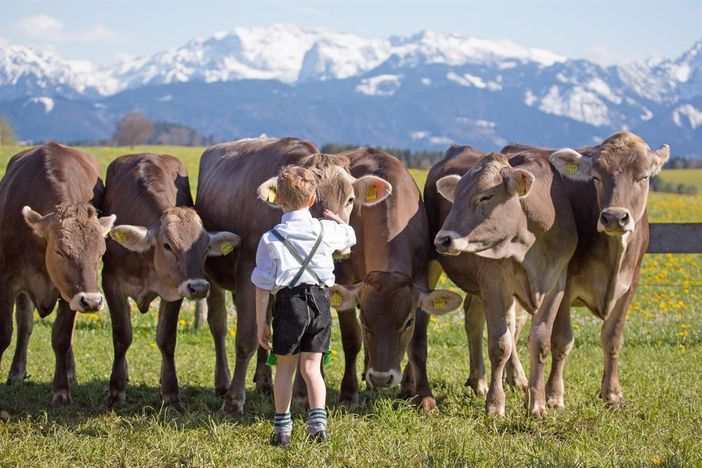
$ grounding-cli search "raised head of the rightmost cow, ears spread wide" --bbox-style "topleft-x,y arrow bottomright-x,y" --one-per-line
549,132 -> 670,237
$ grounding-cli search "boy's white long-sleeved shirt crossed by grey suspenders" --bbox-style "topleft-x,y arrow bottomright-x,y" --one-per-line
251,209 -> 356,294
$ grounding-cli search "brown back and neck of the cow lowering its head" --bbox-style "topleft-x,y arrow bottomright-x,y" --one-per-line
337,148 -> 432,284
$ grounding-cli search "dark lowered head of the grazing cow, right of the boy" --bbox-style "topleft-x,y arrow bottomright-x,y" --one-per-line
331,271 -> 461,387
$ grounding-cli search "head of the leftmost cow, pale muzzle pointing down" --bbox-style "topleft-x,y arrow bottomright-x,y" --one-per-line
22,203 -> 115,312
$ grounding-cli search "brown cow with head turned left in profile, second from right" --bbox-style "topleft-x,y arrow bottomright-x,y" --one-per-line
425,147 -> 577,417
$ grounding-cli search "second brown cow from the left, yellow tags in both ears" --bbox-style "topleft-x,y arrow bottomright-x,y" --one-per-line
102,153 -> 240,406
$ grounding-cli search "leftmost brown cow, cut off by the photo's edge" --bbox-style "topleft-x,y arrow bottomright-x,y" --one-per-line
0,142 -> 115,406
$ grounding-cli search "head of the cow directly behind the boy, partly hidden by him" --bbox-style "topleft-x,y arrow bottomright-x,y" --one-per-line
257,153 -> 392,256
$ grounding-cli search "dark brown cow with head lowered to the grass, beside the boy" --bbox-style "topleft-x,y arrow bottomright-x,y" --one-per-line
318,148 -> 461,411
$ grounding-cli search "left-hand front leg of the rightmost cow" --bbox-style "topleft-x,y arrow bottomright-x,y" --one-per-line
546,298 -> 574,409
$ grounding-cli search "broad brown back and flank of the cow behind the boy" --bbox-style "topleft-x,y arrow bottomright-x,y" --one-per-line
195,138 -> 319,289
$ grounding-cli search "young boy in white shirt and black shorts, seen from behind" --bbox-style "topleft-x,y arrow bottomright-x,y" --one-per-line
251,166 -> 356,446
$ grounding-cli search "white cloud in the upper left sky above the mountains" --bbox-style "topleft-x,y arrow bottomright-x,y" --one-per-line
14,15 -> 117,43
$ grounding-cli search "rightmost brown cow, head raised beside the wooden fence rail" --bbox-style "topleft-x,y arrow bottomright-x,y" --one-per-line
503,132 -> 670,408
